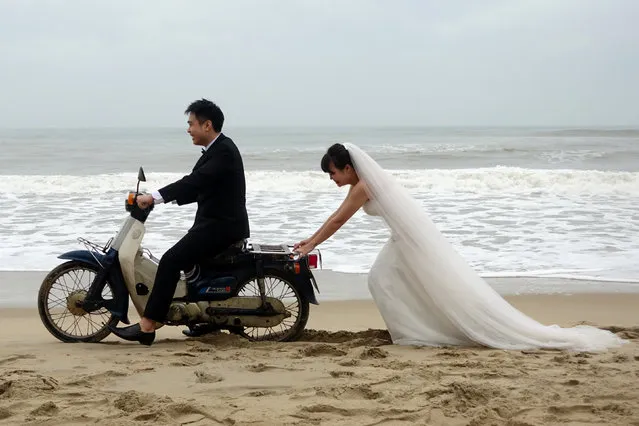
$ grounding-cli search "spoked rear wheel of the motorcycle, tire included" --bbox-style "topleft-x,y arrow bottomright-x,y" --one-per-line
231,271 -> 309,342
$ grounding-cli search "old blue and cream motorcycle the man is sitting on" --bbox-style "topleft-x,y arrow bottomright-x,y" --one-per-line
38,167 -> 321,342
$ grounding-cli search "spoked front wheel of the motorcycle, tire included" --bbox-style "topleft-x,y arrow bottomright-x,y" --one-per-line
38,261 -> 118,342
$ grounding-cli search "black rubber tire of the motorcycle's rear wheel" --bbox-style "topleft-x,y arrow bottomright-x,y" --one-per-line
230,270 -> 310,342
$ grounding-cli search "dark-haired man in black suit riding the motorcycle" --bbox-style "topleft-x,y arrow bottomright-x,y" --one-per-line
110,99 -> 250,345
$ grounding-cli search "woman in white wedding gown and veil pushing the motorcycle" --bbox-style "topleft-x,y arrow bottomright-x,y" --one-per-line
294,144 -> 626,351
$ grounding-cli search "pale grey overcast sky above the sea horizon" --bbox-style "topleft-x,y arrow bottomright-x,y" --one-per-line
0,0 -> 639,127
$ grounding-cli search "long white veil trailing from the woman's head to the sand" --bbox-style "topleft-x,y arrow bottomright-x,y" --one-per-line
345,143 -> 626,351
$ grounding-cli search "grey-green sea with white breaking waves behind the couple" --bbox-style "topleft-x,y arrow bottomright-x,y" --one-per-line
0,127 -> 639,298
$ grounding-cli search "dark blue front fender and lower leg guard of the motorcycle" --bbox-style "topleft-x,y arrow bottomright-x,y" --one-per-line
58,249 -> 130,324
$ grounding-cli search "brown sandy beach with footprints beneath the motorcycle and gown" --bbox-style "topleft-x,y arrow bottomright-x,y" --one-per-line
0,273 -> 639,426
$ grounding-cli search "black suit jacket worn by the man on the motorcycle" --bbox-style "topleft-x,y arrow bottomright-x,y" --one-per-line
159,134 -> 250,240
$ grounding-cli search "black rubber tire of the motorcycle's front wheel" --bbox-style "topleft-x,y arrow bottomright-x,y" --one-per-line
38,260 -> 119,343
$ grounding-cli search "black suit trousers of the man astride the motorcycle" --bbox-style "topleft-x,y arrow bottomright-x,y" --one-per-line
144,231 -> 236,323
